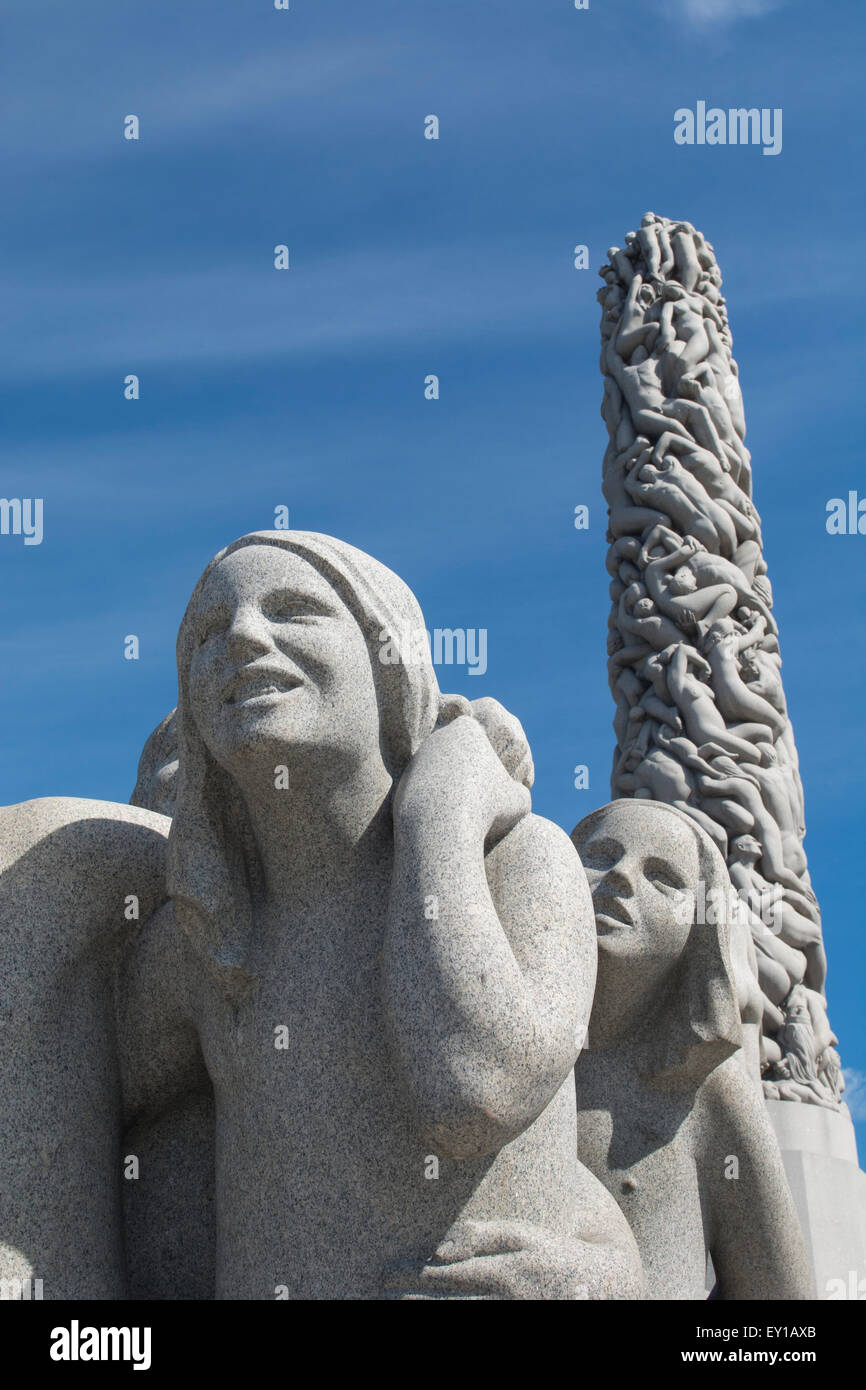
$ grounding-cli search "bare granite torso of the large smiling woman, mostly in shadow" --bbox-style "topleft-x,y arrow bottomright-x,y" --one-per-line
195,891 -> 582,1298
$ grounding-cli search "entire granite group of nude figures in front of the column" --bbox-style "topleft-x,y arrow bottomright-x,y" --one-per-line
0,532 -> 845,1300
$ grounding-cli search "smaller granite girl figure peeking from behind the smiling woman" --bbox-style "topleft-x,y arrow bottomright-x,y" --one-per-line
571,799 -> 813,1300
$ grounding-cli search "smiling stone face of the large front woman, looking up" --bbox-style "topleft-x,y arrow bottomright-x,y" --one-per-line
188,545 -> 379,776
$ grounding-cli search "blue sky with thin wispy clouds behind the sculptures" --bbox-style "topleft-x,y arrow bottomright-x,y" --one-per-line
0,0 -> 866,1138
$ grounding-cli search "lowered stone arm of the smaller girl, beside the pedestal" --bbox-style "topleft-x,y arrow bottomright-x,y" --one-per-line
698,1056 -> 815,1300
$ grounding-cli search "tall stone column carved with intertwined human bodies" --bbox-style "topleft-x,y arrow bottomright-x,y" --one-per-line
599,213 -> 842,1109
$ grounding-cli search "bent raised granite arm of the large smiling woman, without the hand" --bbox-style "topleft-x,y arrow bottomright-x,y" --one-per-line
382,803 -> 596,1158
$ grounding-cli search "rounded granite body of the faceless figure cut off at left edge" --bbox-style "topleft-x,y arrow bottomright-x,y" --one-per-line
0,796 -> 170,1300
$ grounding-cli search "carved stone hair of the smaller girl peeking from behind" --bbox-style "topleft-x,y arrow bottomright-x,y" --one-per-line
571,798 -> 742,1091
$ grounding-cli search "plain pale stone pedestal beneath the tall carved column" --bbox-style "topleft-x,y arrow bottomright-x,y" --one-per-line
767,1101 -> 866,1300
